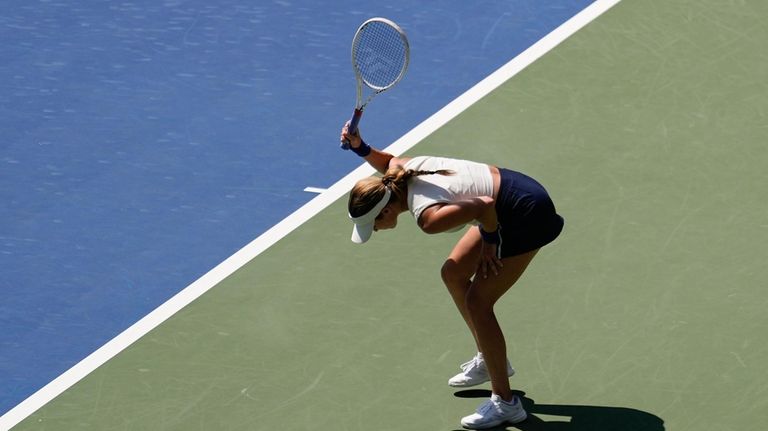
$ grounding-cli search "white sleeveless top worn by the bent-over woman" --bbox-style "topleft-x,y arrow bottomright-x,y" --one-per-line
403,156 -> 493,231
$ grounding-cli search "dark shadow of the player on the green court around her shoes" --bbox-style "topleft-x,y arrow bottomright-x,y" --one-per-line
454,389 -> 664,431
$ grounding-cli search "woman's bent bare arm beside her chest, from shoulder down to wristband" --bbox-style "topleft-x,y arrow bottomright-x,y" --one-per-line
418,196 -> 498,233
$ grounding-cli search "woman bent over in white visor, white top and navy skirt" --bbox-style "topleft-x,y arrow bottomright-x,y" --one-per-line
341,123 -> 563,429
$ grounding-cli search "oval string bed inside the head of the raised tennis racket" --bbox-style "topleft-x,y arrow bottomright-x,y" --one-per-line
354,22 -> 408,90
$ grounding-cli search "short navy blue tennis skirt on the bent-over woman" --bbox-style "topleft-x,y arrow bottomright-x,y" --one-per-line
496,168 -> 565,258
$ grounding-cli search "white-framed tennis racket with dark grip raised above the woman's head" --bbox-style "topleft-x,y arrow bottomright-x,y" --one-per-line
341,18 -> 410,150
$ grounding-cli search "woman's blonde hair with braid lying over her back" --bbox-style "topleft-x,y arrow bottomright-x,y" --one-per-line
347,165 -> 454,217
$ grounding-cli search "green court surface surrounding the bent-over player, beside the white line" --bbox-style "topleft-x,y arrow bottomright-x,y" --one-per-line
14,0 -> 768,431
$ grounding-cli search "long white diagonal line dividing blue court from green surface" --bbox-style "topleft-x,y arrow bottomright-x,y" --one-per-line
0,0 -> 620,430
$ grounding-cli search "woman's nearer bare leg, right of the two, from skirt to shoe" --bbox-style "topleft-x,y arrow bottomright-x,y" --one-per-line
466,249 -> 538,401
